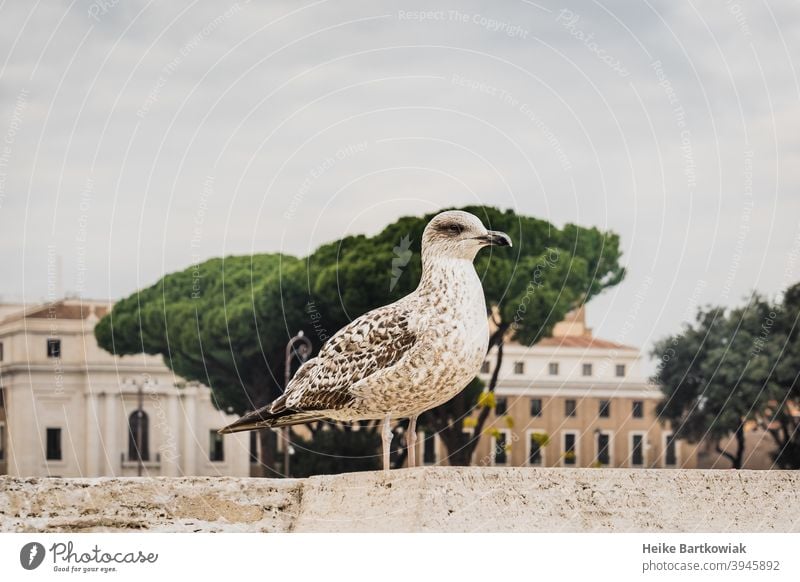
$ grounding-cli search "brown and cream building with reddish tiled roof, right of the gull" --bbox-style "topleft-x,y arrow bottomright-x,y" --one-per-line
423,309 -> 697,468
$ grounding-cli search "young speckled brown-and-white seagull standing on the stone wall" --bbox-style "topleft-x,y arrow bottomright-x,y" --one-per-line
219,210 -> 511,471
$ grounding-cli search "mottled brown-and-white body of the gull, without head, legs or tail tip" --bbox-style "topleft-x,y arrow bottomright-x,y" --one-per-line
271,259 -> 489,420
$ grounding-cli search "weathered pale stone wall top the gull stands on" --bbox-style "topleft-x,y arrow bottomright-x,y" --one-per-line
0,467 -> 800,532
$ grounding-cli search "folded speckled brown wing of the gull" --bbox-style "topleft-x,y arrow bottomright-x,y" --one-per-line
280,304 -> 417,412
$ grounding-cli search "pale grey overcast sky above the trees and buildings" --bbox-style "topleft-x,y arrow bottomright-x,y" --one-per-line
0,0 -> 800,364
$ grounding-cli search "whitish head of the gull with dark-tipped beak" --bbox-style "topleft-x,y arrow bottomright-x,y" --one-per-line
422,210 -> 511,261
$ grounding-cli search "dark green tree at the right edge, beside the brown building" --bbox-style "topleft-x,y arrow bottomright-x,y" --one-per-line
653,285 -> 800,469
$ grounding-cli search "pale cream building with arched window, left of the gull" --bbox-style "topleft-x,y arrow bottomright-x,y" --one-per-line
0,300 -> 250,477
